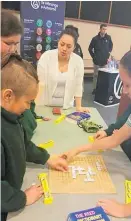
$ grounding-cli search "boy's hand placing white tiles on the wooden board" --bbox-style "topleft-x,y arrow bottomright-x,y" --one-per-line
47,156 -> 68,172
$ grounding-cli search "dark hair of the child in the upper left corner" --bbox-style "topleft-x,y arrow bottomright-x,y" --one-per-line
1,9 -> 23,37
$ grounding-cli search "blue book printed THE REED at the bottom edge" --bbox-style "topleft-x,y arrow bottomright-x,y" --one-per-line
67,207 -> 110,221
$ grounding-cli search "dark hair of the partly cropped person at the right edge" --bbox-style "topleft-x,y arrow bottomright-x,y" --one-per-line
120,50 -> 131,77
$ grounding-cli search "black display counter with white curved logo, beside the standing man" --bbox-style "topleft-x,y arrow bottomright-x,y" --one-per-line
94,68 -> 122,107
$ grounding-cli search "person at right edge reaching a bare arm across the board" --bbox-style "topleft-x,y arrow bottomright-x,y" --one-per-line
62,51 -> 131,218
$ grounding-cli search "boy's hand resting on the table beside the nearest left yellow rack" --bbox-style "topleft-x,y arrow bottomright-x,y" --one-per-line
25,185 -> 43,206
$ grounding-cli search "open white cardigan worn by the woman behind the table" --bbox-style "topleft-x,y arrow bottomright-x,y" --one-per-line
37,49 -> 84,109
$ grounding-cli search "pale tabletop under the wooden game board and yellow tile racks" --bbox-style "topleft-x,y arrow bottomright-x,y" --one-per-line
8,107 -> 131,221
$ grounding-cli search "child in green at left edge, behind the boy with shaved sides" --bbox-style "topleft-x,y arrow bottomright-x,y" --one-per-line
1,9 -> 48,140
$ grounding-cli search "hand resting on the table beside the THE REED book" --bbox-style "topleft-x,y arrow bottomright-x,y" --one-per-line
97,200 -> 125,218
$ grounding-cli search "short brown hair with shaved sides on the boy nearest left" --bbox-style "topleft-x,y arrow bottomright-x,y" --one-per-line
1,53 -> 39,97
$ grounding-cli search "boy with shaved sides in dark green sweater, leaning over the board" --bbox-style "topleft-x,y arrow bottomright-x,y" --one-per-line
1,54 -> 68,221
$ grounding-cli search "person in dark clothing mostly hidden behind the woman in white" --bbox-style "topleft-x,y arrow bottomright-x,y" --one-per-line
65,25 -> 83,59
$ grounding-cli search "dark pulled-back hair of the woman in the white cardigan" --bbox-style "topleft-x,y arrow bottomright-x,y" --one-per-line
59,28 -> 78,45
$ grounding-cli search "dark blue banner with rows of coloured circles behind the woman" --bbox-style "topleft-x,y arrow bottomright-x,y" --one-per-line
20,1 -> 65,66
